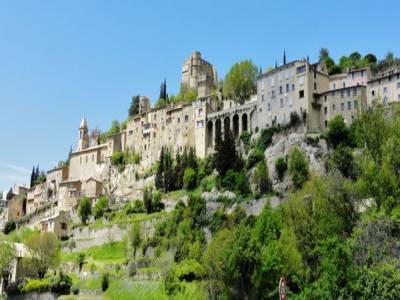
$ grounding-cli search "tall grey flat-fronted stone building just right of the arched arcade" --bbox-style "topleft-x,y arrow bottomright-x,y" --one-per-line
257,59 -> 329,129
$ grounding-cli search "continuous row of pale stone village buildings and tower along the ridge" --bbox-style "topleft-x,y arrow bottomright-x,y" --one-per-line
0,51 -> 400,231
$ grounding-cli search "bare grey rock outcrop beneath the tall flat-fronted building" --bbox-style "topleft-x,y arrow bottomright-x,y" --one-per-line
265,132 -> 328,195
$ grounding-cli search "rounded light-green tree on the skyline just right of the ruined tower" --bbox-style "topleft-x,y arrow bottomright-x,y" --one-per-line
223,60 -> 258,104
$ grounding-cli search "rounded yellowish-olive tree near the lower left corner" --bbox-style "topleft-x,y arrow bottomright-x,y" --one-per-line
26,232 -> 60,278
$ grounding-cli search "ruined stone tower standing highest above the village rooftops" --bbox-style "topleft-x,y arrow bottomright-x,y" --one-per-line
181,51 -> 218,98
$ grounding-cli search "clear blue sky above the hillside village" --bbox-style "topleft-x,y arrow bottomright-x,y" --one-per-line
0,0 -> 400,190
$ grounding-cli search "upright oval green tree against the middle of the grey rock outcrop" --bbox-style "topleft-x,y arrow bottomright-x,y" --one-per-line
289,147 -> 310,189
